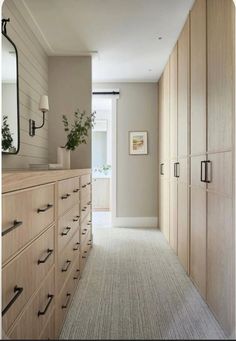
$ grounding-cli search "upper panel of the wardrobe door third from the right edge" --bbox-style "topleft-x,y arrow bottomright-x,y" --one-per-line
178,18 -> 189,157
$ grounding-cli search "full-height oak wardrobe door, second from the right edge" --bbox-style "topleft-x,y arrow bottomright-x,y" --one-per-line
189,0 -> 207,298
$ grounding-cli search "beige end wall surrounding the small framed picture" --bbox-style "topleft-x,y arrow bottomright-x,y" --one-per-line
93,83 -> 158,217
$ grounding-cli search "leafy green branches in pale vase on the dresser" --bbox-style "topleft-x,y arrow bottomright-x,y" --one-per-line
57,109 -> 95,169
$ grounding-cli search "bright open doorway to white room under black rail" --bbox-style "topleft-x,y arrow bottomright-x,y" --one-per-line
92,95 -> 113,227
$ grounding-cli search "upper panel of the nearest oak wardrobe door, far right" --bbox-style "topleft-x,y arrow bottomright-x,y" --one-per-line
207,0 -> 234,152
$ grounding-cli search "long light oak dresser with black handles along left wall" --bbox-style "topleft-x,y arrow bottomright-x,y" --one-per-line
2,170 -> 93,339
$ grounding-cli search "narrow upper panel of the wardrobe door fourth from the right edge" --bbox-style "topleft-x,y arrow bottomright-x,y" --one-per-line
170,45 -> 178,160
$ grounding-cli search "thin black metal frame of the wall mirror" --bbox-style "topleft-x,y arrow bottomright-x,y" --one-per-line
2,19 -> 20,155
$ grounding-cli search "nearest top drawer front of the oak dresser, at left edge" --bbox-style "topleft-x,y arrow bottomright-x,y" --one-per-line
2,184 -> 55,263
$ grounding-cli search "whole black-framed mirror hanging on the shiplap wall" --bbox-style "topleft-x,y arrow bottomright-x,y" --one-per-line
2,19 -> 20,154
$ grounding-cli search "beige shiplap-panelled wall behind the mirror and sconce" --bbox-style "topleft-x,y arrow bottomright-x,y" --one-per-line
2,0 -> 48,168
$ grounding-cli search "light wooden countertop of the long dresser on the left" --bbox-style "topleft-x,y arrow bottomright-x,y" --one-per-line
2,169 -> 91,193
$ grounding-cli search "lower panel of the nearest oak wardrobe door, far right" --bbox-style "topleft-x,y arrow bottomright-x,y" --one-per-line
207,193 -> 234,334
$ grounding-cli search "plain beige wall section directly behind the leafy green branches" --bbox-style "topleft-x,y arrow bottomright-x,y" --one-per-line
49,57 -> 91,168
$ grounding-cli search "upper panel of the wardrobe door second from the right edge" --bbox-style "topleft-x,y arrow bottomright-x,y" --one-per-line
190,0 -> 206,154
